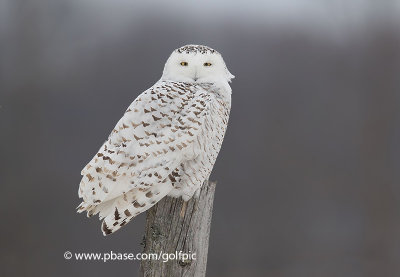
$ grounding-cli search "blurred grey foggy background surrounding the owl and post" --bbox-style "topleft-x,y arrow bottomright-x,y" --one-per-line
0,0 -> 400,277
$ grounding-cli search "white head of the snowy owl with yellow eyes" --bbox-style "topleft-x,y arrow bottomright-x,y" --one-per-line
161,45 -> 235,83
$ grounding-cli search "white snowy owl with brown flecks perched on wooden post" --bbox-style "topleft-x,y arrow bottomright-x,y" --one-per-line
78,45 -> 234,235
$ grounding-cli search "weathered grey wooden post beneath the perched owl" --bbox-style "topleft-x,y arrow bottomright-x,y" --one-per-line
140,181 -> 216,277
